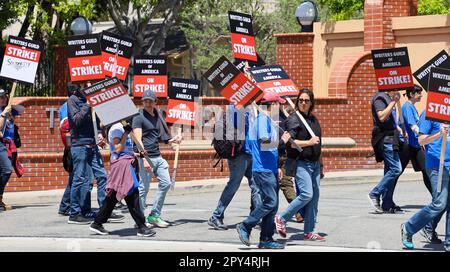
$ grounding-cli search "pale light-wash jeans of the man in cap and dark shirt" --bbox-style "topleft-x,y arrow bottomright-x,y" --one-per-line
139,156 -> 171,217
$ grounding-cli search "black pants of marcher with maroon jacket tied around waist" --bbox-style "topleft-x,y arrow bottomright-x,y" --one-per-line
94,189 -> 145,227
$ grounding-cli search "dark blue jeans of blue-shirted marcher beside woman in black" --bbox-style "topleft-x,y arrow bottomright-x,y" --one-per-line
242,172 -> 279,241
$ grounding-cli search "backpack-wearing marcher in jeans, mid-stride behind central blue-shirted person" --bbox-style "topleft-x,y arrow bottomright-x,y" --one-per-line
208,105 -> 261,230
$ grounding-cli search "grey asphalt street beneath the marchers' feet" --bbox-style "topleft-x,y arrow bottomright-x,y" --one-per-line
0,177 -> 445,251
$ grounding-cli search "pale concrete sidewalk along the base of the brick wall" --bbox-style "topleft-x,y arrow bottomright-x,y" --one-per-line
4,168 -> 422,205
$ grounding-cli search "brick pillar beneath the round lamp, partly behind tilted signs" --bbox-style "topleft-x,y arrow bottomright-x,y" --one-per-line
274,33 -> 314,89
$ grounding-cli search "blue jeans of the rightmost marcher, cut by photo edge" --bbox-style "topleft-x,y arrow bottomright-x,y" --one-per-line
405,167 -> 450,246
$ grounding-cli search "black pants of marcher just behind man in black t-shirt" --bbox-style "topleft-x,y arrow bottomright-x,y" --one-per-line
394,143 -> 432,194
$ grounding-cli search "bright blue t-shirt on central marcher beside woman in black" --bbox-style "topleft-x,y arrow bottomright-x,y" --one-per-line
248,114 -> 278,175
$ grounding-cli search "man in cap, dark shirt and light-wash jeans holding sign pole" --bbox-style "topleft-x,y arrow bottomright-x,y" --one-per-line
132,90 -> 181,228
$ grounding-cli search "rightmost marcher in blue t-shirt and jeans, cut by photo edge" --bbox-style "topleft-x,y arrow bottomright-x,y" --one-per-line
401,113 -> 450,252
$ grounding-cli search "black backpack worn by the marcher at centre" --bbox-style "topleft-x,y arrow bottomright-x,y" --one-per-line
211,114 -> 244,167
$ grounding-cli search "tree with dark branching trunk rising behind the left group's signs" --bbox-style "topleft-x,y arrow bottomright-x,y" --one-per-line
107,0 -> 186,55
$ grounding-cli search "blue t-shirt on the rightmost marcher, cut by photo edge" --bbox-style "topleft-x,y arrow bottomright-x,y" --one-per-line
419,111 -> 450,168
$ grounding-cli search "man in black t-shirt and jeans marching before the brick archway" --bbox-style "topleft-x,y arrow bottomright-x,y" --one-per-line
368,92 -> 402,213
